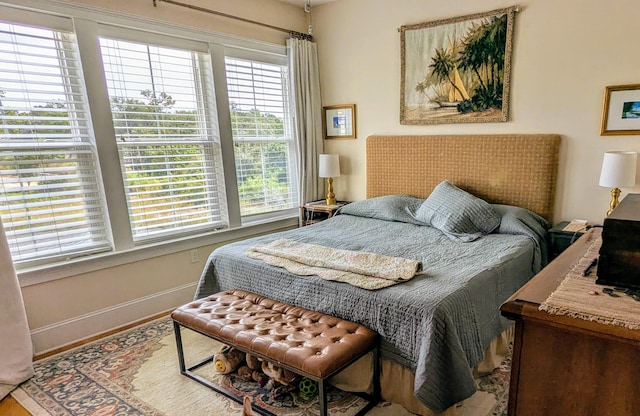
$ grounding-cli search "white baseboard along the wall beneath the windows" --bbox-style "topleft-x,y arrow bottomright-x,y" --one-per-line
31,283 -> 196,355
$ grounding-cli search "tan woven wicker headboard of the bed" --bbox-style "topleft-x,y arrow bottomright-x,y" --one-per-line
367,134 -> 560,221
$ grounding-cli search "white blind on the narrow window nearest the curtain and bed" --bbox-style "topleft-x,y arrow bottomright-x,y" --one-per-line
226,56 -> 298,216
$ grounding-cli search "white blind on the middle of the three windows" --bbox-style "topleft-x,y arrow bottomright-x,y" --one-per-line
100,37 -> 228,242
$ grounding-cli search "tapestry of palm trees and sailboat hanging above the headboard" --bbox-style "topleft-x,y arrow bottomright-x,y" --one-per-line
400,6 -> 517,124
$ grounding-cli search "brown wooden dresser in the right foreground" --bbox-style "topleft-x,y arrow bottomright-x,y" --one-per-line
501,228 -> 640,416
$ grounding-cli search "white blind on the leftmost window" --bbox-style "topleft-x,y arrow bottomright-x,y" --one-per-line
0,18 -> 111,264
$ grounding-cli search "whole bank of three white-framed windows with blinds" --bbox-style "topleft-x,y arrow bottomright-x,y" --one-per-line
0,4 -> 297,275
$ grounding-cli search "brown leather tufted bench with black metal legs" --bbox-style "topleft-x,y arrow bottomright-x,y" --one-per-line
171,290 -> 380,416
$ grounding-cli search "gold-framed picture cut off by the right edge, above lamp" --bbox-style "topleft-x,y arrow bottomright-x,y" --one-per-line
600,84 -> 640,136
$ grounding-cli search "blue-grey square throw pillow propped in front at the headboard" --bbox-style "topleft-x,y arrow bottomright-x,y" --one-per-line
416,180 -> 501,242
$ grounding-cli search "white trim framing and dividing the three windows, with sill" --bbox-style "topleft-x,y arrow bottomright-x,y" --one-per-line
0,0 -> 299,287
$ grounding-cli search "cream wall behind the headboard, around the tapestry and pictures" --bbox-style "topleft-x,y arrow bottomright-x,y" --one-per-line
312,0 -> 640,223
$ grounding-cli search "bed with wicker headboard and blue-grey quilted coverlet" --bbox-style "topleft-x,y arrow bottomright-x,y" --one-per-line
195,135 -> 560,415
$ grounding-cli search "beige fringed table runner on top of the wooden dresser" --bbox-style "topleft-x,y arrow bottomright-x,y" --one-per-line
539,237 -> 640,329
